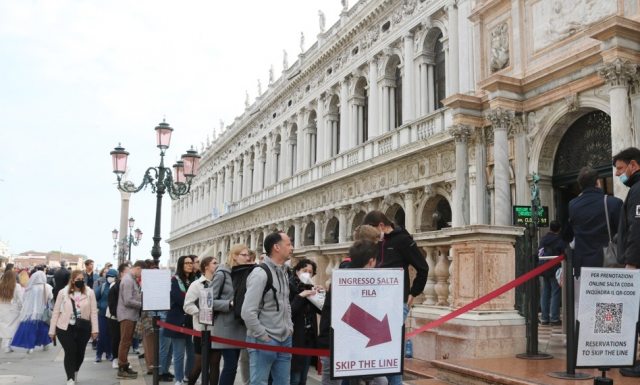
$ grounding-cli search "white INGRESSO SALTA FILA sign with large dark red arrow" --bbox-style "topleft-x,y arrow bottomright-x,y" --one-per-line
331,269 -> 404,378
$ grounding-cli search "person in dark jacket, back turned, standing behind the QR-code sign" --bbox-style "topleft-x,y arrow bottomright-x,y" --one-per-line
563,167 -> 622,314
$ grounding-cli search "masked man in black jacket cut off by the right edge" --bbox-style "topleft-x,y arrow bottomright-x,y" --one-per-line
613,147 -> 640,377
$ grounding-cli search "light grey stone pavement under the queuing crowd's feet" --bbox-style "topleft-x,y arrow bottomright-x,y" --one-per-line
0,344 -> 320,385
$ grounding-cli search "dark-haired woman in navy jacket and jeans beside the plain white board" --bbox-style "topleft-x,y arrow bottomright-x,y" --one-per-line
163,255 -> 195,385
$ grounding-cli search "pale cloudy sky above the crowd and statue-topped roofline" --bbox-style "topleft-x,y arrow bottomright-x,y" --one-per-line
0,0 -> 344,265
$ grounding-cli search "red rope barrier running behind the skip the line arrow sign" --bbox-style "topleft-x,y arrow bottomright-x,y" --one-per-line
158,254 -> 565,357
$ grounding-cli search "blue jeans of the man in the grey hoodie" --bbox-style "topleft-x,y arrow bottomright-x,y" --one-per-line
247,336 -> 291,385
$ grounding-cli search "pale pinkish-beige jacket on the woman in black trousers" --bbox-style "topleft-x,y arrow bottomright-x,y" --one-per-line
49,287 -> 98,335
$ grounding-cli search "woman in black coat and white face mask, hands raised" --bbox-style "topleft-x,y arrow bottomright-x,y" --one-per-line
289,259 -> 322,385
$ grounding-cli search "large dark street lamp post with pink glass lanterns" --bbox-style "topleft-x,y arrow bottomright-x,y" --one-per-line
111,120 -> 200,266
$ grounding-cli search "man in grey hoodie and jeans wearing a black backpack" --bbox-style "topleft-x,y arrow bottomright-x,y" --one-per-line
241,231 -> 293,385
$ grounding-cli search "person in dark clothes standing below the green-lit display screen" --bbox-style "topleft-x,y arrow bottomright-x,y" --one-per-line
538,221 -> 566,326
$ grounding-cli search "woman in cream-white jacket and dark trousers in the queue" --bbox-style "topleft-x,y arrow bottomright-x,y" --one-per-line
184,257 -> 220,385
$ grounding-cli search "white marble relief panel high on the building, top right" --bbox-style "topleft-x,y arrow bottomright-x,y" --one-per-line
531,0 -> 618,51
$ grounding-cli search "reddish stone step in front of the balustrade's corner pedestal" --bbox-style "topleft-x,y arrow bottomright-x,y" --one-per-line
432,357 -> 640,385
